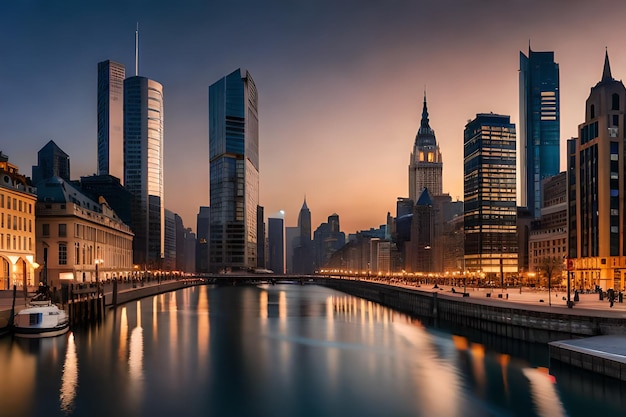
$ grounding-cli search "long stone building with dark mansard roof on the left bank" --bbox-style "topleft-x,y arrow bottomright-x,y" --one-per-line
35,177 -> 133,289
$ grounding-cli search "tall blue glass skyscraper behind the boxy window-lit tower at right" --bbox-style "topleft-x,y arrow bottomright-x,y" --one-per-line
519,47 -> 561,218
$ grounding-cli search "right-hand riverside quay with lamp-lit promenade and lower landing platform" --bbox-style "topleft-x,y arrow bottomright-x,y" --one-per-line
327,279 -> 626,381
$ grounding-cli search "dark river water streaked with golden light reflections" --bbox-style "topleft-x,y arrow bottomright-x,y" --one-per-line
0,285 -> 624,417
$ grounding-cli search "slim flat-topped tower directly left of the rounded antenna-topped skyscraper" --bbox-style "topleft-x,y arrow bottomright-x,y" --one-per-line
98,60 -> 126,181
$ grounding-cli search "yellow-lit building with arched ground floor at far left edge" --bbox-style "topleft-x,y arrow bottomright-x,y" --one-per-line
0,152 -> 39,290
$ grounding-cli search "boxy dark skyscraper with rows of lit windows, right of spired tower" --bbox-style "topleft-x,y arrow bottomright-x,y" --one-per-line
463,113 -> 517,279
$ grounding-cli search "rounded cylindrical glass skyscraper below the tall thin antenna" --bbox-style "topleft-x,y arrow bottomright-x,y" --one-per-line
124,76 -> 165,269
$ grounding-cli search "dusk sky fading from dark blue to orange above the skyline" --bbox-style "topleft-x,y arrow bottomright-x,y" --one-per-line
0,0 -> 626,233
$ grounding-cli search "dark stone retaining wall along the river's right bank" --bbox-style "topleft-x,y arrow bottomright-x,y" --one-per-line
318,279 -> 626,343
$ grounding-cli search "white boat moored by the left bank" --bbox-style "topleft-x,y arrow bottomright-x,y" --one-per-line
13,297 -> 70,338
